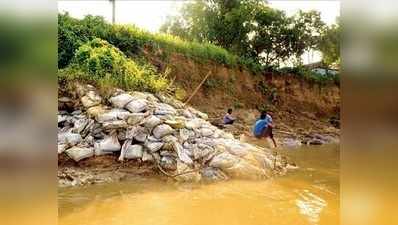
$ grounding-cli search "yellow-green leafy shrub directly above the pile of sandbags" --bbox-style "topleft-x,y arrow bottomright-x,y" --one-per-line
59,38 -> 169,92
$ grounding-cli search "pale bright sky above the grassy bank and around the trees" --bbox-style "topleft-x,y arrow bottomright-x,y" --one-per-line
58,0 -> 340,63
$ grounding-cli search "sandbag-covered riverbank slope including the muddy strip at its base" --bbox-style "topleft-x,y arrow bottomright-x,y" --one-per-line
58,83 -> 293,186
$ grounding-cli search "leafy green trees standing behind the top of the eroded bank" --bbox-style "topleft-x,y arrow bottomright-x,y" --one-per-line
161,0 -> 326,67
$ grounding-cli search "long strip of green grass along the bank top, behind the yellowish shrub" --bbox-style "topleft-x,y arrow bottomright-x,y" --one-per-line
58,13 -> 260,71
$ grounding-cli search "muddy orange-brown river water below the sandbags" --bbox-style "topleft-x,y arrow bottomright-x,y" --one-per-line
59,145 -> 339,225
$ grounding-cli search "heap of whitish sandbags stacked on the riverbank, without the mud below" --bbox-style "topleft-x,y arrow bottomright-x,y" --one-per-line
58,84 -> 290,181
